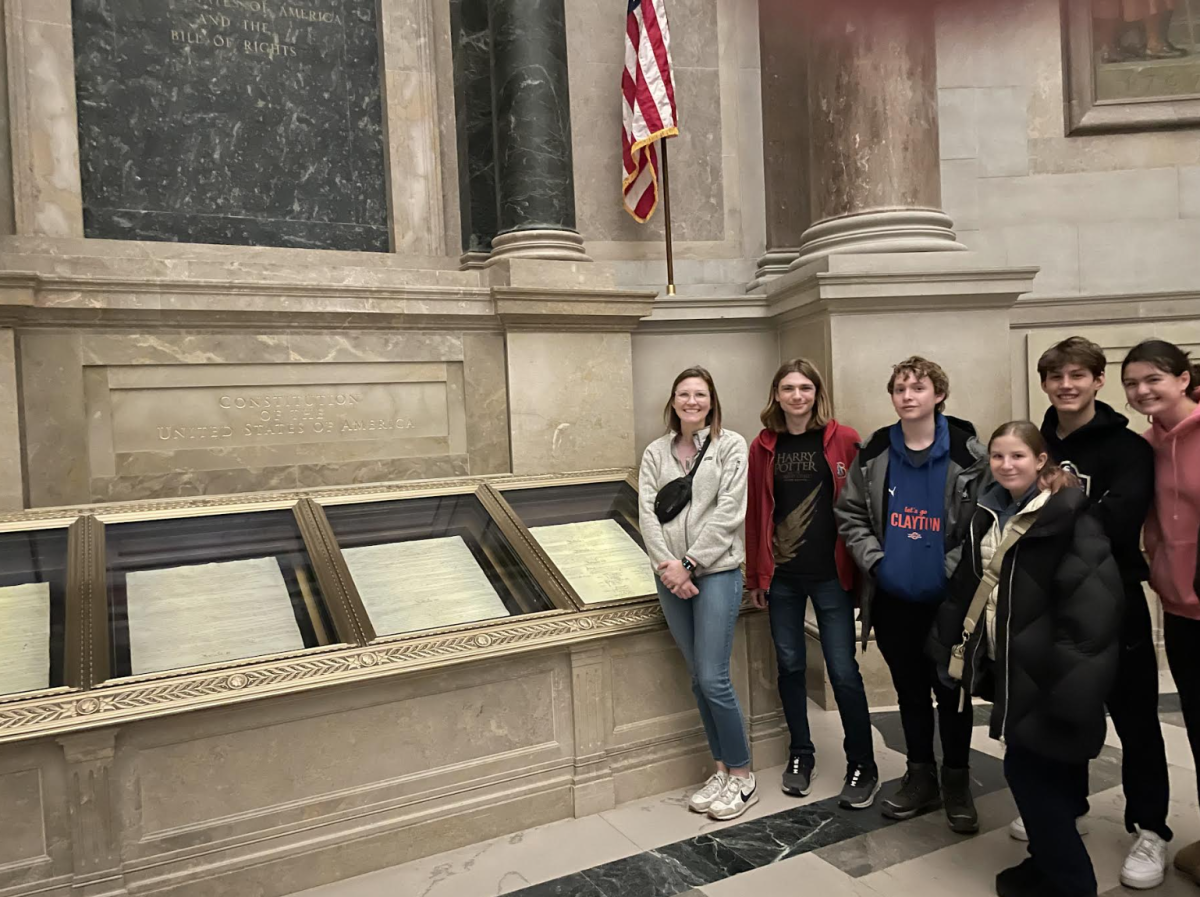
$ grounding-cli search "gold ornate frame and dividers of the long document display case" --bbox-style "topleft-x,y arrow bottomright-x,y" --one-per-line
0,470 -> 662,744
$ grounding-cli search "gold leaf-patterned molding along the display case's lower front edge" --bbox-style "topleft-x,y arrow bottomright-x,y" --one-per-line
0,602 -> 662,744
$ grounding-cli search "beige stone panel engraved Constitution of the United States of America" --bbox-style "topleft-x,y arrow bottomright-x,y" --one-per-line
112,383 -> 449,452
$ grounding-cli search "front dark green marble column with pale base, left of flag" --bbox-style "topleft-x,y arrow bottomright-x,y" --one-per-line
488,0 -> 587,261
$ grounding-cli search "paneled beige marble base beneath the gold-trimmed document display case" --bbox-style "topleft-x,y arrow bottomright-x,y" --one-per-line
0,614 -> 786,897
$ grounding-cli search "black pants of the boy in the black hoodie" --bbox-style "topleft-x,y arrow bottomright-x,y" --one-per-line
1108,583 -> 1171,841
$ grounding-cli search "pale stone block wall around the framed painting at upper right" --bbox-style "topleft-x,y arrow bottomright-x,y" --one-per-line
937,0 -> 1200,297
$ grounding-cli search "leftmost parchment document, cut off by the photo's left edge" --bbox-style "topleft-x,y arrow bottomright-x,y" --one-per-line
0,583 -> 50,694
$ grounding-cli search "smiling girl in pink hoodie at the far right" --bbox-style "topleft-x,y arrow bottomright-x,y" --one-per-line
1121,339 -> 1200,884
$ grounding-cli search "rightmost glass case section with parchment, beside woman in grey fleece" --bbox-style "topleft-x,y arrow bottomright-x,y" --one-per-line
497,476 -> 655,607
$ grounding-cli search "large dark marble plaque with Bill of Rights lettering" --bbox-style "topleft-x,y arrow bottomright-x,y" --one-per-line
72,0 -> 388,252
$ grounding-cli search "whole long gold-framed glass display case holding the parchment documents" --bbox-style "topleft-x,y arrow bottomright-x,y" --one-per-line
0,470 -> 661,742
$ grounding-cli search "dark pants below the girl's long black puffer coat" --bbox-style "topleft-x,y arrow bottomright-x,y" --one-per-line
1004,746 -> 1096,897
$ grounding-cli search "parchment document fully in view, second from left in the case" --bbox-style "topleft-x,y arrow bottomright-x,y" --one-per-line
125,558 -> 305,675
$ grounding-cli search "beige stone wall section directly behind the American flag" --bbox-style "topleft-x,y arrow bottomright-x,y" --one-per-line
566,0 -> 766,287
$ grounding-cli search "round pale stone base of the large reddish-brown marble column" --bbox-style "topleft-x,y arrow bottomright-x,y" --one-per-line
792,209 -> 967,271
